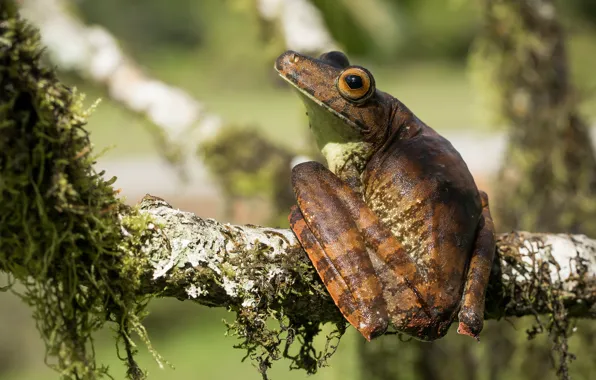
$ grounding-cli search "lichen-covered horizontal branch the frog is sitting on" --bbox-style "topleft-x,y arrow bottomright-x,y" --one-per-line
140,196 -> 596,323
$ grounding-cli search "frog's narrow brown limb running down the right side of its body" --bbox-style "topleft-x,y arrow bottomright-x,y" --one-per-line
457,191 -> 495,338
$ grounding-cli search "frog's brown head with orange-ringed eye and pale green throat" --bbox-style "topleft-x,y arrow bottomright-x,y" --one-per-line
275,51 -> 398,150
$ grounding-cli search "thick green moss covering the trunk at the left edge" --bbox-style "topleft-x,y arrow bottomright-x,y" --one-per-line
0,7 -> 158,379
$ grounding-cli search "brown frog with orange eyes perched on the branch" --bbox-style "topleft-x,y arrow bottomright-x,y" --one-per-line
274,51 -> 495,341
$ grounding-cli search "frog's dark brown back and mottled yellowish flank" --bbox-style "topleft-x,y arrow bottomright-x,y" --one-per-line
363,122 -> 482,308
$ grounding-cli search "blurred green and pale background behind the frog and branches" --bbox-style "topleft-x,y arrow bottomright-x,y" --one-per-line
0,0 -> 596,380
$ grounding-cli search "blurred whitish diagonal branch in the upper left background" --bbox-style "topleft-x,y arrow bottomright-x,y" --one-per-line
20,0 -> 225,175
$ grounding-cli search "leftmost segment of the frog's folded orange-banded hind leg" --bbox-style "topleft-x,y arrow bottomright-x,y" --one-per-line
292,162 -> 388,339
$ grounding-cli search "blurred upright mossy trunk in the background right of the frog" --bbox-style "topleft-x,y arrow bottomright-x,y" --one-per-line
471,0 -> 596,379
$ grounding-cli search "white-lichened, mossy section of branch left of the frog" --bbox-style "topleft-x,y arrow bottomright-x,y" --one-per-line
140,196 -> 346,376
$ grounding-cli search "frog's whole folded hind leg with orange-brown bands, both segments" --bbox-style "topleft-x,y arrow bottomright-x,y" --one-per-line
292,162 -> 426,339
